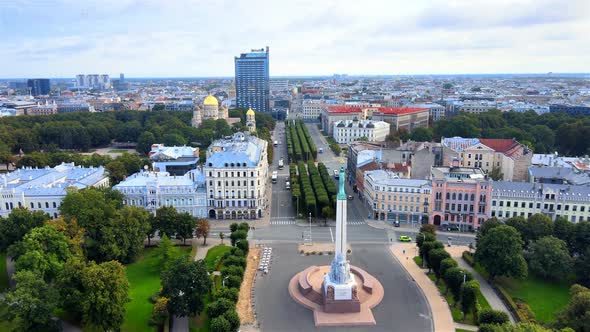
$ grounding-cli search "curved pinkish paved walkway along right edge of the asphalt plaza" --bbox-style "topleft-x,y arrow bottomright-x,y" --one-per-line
389,243 -> 455,332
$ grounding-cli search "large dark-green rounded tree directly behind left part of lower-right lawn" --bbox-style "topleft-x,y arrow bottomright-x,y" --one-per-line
475,225 -> 527,280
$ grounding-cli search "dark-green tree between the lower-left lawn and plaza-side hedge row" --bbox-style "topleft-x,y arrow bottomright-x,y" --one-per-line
161,256 -> 211,317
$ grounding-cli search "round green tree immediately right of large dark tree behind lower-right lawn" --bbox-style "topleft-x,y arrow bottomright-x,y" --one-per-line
526,236 -> 573,280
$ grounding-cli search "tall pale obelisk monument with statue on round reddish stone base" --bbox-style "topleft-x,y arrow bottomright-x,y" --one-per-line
289,167 -> 384,326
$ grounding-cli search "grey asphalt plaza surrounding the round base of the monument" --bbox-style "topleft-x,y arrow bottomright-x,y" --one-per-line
254,244 -> 432,332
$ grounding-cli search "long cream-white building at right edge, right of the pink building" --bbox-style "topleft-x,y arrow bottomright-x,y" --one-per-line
491,181 -> 590,223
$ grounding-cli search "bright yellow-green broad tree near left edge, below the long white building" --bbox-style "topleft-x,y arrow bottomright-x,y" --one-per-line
8,226 -> 72,281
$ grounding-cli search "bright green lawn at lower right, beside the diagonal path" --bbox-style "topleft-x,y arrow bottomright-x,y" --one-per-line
498,276 -> 569,323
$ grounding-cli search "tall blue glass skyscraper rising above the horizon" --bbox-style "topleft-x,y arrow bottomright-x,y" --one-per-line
235,46 -> 270,112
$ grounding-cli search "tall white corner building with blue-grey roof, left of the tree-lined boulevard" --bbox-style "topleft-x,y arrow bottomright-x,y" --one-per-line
203,133 -> 269,219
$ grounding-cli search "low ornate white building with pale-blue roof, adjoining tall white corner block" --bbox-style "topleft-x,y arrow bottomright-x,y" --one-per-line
113,169 -> 207,218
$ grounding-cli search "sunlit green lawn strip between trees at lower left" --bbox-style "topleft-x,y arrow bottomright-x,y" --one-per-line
122,247 -> 191,331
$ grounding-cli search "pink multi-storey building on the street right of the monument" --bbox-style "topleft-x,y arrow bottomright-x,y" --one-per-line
429,163 -> 492,230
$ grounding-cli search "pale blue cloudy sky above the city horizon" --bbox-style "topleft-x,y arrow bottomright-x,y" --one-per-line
0,0 -> 590,78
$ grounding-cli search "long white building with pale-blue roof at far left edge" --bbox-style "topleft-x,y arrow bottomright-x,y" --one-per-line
0,163 -> 109,218
